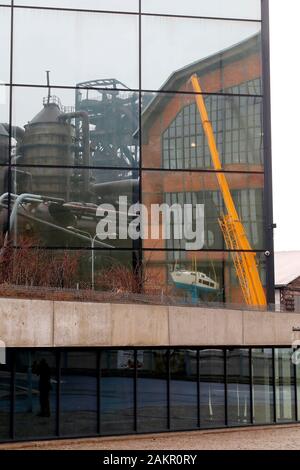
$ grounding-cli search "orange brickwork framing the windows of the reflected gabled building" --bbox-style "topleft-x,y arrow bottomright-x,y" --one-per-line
142,48 -> 264,304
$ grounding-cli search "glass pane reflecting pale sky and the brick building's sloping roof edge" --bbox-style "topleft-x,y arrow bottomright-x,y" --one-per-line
142,16 -> 261,92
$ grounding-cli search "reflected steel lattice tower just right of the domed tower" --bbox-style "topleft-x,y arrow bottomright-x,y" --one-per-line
75,79 -> 139,183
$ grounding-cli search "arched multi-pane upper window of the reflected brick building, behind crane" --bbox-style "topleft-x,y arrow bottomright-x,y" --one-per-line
162,79 -> 263,169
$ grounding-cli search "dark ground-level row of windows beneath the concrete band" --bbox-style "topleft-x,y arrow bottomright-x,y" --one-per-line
0,347 -> 300,442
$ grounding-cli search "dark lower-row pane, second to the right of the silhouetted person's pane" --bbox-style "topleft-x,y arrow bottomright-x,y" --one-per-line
100,349 -> 134,434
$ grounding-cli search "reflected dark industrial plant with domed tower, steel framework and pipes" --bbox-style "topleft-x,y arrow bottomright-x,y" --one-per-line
0,78 -> 139,252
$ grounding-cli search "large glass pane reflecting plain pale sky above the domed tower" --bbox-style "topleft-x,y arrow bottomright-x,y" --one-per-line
14,9 -> 138,88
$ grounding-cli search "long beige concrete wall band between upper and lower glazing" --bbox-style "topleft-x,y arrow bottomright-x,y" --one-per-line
0,298 -> 300,347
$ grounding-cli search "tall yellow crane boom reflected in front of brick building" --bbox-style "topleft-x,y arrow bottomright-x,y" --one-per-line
191,74 -> 267,307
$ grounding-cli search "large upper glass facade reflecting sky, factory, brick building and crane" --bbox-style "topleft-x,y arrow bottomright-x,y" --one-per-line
0,0 -> 273,308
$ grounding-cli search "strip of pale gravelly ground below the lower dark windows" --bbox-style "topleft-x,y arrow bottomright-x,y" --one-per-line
0,425 -> 300,451
